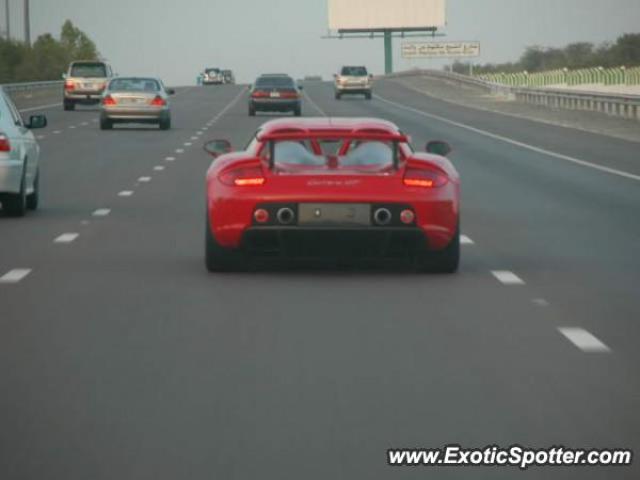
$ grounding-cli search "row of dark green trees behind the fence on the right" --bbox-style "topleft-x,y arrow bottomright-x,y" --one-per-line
453,33 -> 640,75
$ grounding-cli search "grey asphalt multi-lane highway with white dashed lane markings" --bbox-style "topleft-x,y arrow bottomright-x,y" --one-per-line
0,81 -> 640,480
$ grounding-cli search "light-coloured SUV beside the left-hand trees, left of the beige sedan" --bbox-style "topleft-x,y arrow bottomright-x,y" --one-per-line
63,61 -> 113,110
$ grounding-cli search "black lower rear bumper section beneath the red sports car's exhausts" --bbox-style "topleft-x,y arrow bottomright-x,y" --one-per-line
241,227 -> 427,260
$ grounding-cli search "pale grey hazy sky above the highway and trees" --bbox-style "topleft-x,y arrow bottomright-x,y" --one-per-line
5,0 -> 640,85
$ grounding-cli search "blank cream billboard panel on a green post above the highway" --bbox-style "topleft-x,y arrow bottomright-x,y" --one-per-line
329,0 -> 446,31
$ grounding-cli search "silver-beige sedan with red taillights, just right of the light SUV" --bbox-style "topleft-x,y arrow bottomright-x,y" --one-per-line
100,77 -> 175,130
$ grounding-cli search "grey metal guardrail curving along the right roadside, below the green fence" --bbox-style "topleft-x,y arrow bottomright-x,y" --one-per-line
387,70 -> 640,120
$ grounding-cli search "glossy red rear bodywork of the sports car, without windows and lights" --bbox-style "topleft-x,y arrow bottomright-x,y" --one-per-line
207,118 -> 460,255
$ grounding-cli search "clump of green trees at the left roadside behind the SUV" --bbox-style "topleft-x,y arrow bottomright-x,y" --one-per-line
0,20 -> 100,84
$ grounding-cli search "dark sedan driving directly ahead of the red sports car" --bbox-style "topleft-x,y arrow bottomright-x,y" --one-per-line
249,74 -> 302,117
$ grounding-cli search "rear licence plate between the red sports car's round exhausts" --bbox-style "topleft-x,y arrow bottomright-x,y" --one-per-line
298,203 -> 371,226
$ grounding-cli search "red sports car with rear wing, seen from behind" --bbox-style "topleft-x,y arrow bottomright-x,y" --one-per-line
205,118 -> 460,273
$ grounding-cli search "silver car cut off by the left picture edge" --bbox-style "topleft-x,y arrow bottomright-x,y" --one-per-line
0,88 -> 47,217
